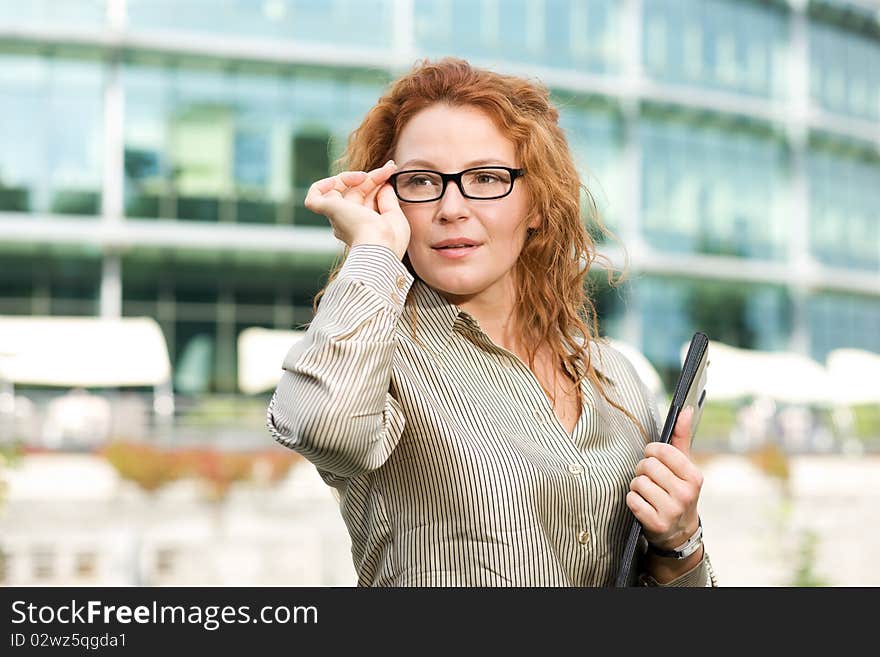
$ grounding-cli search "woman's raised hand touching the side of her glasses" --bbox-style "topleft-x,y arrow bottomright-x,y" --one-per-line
305,160 -> 410,259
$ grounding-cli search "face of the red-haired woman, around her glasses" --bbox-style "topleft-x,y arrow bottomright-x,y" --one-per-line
394,105 -> 537,305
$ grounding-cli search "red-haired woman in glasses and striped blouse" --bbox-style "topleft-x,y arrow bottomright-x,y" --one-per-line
268,59 -> 709,586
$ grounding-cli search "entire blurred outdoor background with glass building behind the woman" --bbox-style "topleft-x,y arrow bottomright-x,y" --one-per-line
0,0 -> 880,586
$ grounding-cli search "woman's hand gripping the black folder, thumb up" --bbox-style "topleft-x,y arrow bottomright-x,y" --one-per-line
626,408 -> 703,550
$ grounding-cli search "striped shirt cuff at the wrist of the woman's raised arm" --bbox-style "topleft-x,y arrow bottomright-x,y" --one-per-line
339,244 -> 415,311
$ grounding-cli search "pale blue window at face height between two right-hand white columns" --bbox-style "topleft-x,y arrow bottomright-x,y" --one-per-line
639,117 -> 790,260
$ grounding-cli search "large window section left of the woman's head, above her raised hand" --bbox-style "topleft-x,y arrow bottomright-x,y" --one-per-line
123,61 -> 385,226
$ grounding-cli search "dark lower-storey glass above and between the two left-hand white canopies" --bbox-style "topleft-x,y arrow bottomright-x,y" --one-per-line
120,249 -> 331,394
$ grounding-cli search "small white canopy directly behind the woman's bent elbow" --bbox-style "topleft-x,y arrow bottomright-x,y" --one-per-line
238,327 -> 305,395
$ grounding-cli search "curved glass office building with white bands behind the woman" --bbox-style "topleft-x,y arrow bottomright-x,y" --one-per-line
0,0 -> 880,393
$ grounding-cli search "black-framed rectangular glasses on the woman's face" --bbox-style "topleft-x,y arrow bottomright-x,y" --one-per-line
388,166 -> 525,203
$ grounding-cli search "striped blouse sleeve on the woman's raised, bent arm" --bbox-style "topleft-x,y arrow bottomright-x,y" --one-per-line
267,245 -> 413,477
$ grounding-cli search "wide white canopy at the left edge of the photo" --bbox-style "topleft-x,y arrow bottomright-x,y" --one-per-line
0,316 -> 171,388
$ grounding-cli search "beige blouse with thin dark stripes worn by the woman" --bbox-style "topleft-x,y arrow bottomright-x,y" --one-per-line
268,245 -> 707,586
